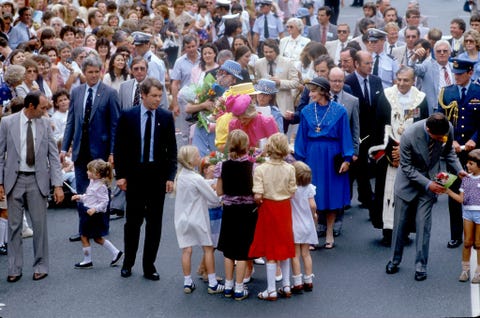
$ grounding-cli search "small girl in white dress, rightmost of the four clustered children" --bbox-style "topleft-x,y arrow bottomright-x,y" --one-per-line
291,161 -> 318,294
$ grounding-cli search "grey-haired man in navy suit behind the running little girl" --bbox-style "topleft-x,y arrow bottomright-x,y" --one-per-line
60,57 -> 119,242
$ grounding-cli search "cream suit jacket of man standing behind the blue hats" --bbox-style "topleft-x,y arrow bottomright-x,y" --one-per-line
255,56 -> 300,114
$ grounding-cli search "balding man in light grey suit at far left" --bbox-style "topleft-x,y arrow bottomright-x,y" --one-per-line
0,91 -> 63,283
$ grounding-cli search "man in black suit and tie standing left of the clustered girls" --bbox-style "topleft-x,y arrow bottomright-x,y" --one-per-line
115,78 -> 177,280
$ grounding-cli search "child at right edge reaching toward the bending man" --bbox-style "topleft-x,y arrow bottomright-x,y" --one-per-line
446,149 -> 480,284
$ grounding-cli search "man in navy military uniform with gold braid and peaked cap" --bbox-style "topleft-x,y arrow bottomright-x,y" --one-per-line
439,59 -> 480,248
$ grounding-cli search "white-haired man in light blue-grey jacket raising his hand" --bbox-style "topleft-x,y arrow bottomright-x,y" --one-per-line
410,39 -> 455,114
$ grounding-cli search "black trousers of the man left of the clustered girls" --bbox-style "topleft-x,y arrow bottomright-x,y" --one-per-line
123,165 -> 166,274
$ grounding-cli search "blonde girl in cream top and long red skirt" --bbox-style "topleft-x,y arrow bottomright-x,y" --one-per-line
249,133 -> 297,300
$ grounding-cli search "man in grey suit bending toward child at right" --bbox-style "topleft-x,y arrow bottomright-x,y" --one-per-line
386,113 -> 467,281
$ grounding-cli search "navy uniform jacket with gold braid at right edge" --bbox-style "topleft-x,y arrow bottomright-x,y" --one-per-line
438,83 -> 480,148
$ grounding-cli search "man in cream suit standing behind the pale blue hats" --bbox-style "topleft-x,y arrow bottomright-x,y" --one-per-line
255,39 -> 300,132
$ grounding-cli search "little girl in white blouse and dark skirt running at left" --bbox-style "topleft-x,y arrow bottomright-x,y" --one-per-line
72,159 -> 123,269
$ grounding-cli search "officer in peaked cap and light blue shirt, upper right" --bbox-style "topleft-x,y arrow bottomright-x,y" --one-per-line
367,28 -> 398,88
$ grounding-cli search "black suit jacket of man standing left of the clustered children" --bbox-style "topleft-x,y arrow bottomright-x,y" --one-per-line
115,107 -> 177,183
